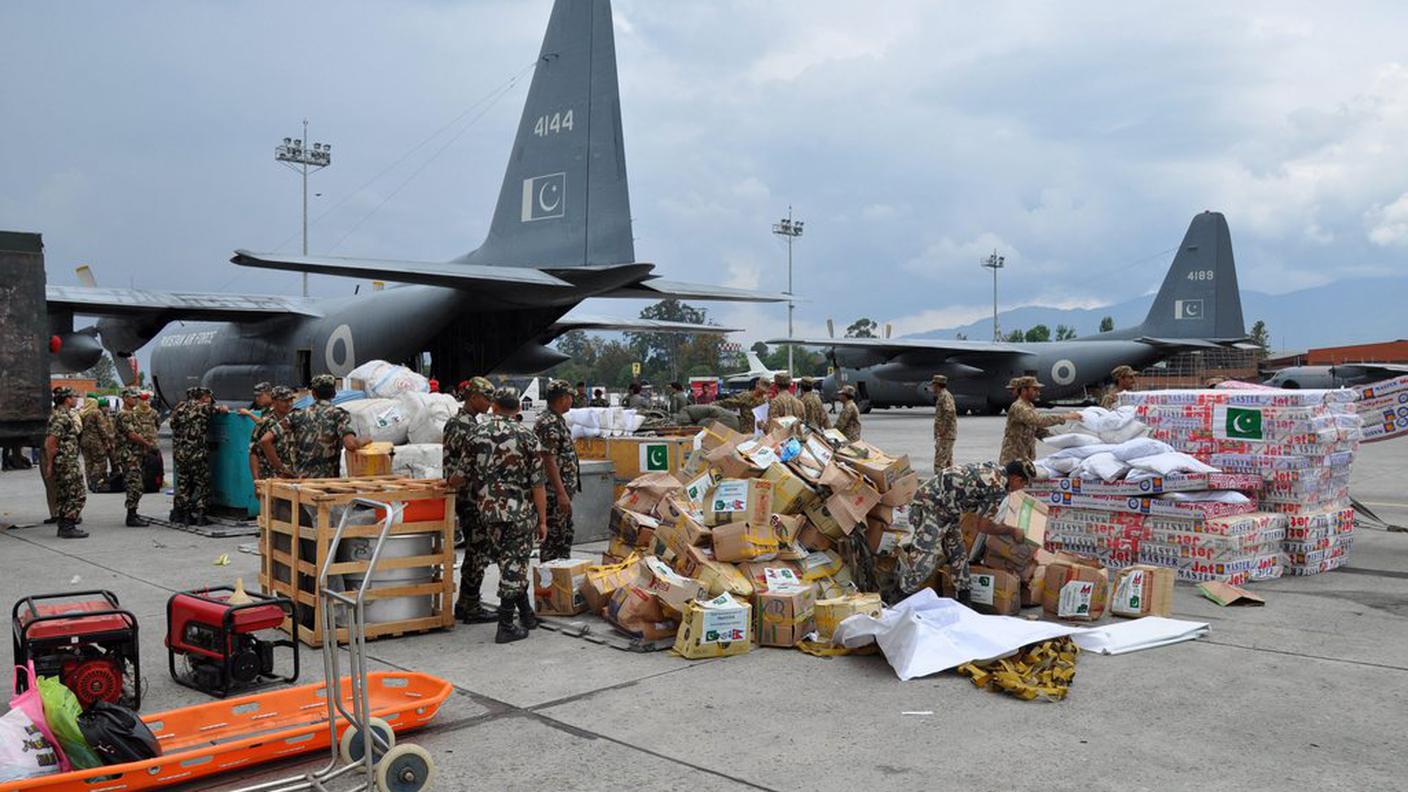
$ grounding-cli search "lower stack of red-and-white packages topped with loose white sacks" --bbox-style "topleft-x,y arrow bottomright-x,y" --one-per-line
1031,406 -> 1287,583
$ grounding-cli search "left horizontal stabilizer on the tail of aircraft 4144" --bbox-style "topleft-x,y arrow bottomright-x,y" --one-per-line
230,249 -> 573,289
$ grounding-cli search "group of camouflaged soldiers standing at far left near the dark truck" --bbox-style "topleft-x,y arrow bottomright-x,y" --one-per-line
41,386 -> 161,538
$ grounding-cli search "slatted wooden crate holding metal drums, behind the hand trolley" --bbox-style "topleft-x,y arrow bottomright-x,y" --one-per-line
259,476 -> 455,647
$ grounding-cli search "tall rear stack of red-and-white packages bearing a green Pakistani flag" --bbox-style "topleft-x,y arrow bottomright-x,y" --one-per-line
1119,389 -> 1363,575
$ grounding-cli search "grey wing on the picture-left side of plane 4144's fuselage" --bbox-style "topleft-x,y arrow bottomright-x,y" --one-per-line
45,285 -> 322,321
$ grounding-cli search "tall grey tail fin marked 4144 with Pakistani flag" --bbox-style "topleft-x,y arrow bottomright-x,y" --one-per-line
456,0 -> 635,268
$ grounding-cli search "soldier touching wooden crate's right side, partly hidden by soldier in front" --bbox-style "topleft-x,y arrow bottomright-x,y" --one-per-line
441,376 -> 498,624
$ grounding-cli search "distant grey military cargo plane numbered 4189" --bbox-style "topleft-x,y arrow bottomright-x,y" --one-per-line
767,211 -> 1247,413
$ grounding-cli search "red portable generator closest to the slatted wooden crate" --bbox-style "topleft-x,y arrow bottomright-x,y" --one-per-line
166,586 -> 298,699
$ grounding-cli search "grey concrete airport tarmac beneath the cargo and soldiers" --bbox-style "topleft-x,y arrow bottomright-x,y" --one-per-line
0,409 -> 1408,792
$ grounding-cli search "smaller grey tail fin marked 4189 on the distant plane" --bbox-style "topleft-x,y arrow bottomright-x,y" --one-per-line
1138,211 -> 1246,338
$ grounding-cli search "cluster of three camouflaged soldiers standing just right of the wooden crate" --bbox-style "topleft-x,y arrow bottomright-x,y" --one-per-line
442,376 -> 584,644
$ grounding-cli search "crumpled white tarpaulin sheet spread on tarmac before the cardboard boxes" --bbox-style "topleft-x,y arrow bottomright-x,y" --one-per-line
834,589 -> 1208,679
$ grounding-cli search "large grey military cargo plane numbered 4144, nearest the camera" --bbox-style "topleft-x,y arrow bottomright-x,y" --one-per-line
48,0 -> 786,404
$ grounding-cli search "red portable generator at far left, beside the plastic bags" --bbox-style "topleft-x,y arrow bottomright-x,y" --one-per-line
10,589 -> 142,709
